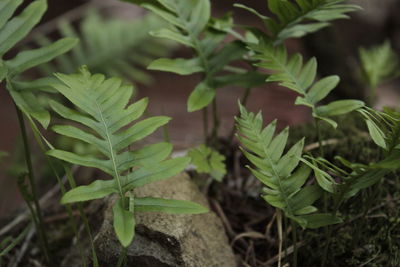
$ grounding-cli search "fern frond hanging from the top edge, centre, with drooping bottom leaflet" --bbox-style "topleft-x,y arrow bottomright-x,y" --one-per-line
129,0 -> 265,112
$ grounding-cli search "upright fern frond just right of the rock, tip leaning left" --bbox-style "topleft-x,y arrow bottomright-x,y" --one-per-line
236,105 -> 341,228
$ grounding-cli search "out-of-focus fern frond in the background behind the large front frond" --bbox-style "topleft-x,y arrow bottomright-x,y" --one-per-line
36,10 -> 172,83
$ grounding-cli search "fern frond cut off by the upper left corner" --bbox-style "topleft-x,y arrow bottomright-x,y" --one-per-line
0,0 -> 77,128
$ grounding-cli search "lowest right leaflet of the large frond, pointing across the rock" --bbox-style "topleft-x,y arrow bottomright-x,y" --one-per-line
135,197 -> 208,214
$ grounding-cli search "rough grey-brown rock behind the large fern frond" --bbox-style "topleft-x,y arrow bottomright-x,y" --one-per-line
95,174 -> 236,267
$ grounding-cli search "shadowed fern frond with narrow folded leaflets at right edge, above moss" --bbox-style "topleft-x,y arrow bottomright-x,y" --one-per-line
307,107 -> 400,201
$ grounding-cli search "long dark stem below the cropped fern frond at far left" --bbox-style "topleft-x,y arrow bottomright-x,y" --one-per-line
14,103 -> 50,262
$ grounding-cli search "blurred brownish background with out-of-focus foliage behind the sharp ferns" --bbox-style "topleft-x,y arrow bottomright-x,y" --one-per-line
0,0 -> 400,218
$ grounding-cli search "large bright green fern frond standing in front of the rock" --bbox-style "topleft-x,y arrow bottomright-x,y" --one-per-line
48,67 -> 207,247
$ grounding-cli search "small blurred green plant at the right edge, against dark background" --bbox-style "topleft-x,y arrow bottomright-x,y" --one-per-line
359,41 -> 400,89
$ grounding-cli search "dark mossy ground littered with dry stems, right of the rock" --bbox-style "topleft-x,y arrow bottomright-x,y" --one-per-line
216,115 -> 400,266
